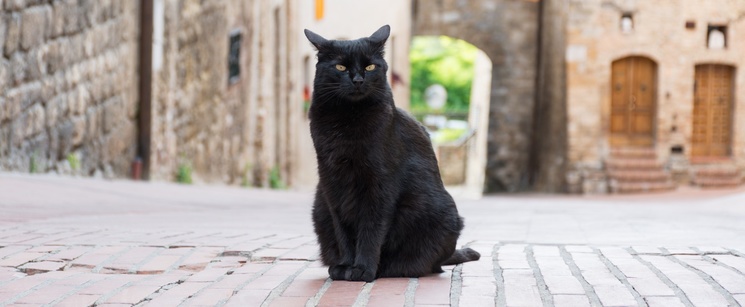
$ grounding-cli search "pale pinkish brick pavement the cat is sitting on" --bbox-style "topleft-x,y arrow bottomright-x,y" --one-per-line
0,174 -> 745,307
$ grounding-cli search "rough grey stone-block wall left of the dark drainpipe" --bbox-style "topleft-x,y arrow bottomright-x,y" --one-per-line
0,0 -> 139,177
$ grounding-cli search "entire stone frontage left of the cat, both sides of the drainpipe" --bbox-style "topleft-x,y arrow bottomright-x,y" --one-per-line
0,0 -> 303,186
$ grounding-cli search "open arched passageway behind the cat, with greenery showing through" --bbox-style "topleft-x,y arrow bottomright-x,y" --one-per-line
410,36 -> 492,199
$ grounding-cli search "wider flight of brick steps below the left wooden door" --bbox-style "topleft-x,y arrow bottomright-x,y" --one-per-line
605,147 -> 675,193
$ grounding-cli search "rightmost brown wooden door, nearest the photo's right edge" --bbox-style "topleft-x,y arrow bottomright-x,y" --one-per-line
691,64 -> 735,158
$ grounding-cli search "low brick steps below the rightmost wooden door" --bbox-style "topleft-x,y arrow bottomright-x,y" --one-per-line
691,161 -> 742,189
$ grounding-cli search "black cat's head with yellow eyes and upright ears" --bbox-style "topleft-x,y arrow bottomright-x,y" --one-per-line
305,25 -> 391,101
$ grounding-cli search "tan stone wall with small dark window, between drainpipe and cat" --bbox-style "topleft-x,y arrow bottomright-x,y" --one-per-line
150,0 -> 302,186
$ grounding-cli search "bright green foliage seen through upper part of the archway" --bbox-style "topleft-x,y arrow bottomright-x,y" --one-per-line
409,36 -> 478,112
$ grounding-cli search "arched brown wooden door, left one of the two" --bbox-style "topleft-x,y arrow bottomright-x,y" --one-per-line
610,57 -> 657,146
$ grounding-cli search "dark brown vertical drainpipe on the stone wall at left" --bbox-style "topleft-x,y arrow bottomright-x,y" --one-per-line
133,0 -> 153,180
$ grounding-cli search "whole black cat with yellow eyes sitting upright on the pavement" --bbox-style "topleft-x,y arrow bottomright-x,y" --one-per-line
305,25 -> 480,282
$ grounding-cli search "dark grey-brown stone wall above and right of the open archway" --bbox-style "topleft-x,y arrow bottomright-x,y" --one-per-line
412,0 -> 538,192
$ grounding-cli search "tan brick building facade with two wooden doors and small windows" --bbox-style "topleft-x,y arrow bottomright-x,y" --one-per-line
563,0 -> 745,193
